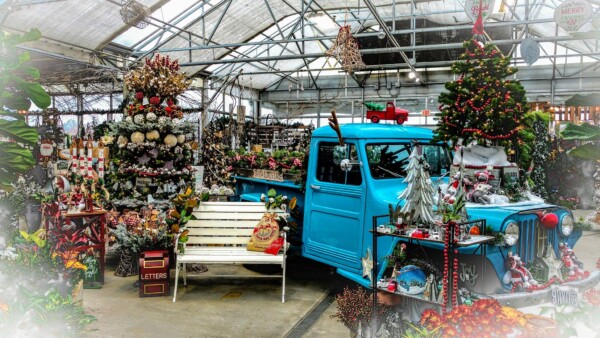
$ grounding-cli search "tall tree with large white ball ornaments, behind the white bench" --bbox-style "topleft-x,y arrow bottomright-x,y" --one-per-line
109,55 -> 195,209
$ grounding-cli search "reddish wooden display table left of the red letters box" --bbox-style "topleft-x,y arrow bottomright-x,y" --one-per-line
45,209 -> 107,284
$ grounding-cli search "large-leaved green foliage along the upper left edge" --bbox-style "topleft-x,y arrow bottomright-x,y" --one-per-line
0,29 -> 50,189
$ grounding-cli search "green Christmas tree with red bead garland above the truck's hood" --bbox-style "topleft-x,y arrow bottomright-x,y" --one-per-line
436,40 -> 527,147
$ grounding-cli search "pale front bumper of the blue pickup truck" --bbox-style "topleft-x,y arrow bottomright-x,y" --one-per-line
490,270 -> 600,308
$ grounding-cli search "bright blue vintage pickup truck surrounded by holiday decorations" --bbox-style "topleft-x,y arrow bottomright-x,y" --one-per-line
235,124 -> 600,307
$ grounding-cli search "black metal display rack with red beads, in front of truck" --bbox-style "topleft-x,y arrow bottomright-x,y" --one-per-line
370,215 -> 494,320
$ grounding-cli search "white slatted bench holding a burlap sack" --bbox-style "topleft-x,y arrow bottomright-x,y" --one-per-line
173,202 -> 288,303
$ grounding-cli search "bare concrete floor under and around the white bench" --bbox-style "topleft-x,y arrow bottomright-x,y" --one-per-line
83,211 -> 600,338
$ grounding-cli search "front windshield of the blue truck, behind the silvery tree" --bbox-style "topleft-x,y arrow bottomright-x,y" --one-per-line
365,143 -> 450,179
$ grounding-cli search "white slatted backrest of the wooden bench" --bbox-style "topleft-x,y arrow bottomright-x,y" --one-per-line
186,202 -> 283,246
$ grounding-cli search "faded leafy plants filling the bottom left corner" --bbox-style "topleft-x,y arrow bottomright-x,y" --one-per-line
0,229 -> 95,337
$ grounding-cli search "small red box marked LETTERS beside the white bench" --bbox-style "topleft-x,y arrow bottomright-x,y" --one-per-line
139,250 -> 171,297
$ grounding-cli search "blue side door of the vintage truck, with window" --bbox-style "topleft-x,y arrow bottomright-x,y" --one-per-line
302,142 -> 366,272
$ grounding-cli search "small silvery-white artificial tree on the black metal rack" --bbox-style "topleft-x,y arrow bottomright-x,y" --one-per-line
398,145 -> 435,224
